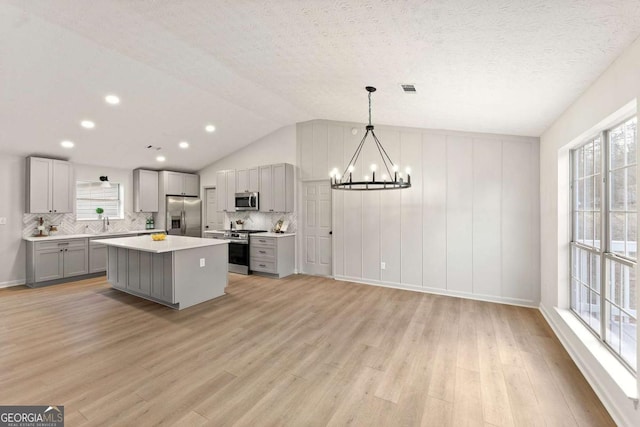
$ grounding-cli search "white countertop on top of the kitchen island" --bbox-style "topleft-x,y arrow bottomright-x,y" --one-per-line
91,236 -> 229,253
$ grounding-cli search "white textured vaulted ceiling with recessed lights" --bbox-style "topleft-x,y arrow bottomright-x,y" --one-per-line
0,0 -> 640,170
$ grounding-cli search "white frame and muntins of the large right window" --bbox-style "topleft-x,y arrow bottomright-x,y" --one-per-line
568,113 -> 640,376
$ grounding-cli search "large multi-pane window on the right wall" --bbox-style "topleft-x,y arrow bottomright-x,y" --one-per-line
570,117 -> 638,371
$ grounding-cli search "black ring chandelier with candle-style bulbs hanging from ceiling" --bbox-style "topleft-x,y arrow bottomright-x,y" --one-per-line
329,86 -> 411,191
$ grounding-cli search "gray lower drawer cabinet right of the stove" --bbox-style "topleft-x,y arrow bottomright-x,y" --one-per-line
249,235 -> 295,277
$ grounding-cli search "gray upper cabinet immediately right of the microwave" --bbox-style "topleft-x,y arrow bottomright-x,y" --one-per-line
260,163 -> 293,212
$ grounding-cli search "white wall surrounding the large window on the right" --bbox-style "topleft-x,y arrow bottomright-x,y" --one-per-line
540,39 -> 640,425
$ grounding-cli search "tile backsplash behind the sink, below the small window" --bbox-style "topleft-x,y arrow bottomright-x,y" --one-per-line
22,212 -> 151,237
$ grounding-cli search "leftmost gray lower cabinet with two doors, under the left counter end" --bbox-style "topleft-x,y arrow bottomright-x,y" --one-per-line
27,238 -> 89,287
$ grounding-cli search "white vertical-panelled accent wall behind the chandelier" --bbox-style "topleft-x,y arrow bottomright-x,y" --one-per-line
297,120 -> 540,306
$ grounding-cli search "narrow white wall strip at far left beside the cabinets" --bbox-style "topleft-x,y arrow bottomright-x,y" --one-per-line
0,154 -> 26,287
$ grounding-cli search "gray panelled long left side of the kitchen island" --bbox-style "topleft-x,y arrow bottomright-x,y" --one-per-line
107,246 -> 176,304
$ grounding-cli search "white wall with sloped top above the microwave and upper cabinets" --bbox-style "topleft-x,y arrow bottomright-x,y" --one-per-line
198,125 -> 296,191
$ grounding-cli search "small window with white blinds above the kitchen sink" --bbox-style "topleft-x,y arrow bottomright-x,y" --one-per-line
76,181 -> 124,220
